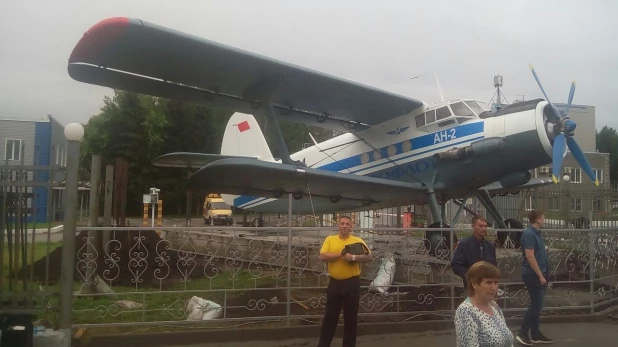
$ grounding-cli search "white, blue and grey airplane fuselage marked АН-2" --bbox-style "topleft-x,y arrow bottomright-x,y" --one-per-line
226,101 -> 552,214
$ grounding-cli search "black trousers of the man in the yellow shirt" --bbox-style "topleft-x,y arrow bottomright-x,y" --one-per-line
318,276 -> 360,347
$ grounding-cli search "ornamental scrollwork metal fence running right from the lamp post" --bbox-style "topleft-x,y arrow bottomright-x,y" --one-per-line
61,227 -> 618,330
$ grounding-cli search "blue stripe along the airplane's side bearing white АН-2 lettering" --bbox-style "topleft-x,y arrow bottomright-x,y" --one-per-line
234,121 -> 485,206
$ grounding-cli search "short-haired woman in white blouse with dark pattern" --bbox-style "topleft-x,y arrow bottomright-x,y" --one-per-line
455,261 -> 514,347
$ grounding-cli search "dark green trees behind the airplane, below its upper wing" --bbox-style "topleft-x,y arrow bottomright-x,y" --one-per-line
80,90 -> 340,215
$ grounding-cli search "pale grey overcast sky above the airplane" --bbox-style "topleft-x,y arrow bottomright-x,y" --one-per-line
0,0 -> 618,129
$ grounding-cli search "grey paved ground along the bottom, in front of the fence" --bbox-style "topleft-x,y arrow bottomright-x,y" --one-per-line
166,322 -> 618,347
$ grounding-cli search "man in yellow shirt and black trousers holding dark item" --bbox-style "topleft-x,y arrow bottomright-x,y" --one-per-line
318,216 -> 373,347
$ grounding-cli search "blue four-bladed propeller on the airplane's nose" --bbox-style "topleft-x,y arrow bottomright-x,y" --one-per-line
530,64 -> 599,186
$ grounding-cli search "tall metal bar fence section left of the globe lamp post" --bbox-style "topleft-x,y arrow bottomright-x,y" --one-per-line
0,150 -> 65,321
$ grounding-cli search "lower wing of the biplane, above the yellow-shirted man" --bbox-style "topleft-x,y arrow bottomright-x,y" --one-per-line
189,158 -> 425,204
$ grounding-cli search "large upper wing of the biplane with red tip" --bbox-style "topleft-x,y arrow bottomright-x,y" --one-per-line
68,18 -> 424,130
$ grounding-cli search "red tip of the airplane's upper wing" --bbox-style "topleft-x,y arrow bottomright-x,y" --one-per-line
69,17 -> 129,64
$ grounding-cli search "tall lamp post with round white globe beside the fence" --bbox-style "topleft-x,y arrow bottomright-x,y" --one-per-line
59,123 -> 83,347
